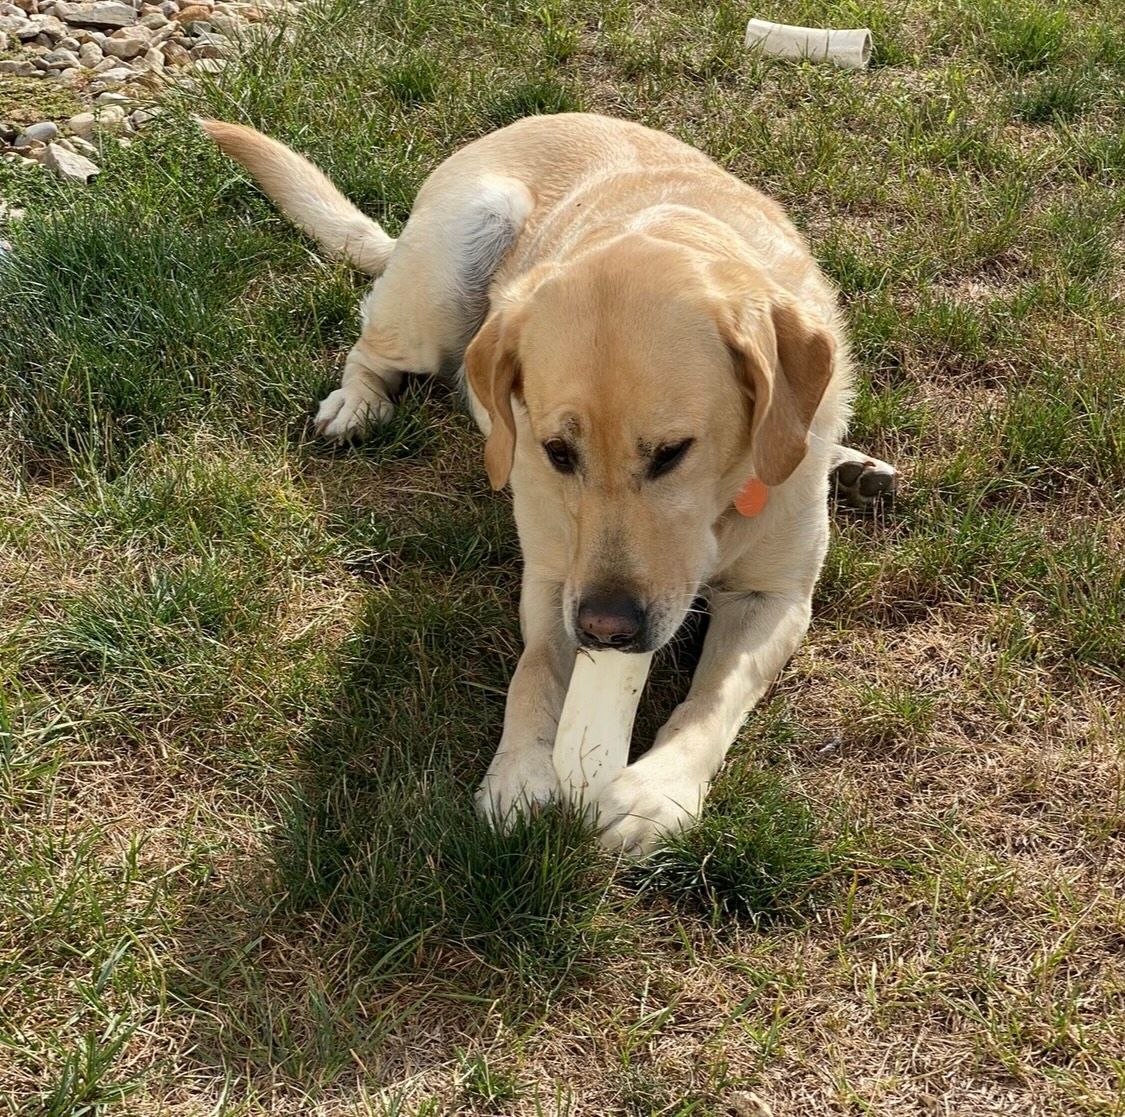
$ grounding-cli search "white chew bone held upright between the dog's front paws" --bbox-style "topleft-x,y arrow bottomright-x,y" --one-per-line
555,650 -> 653,804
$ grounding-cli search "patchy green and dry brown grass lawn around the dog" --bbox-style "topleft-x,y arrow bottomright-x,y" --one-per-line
0,0 -> 1125,1117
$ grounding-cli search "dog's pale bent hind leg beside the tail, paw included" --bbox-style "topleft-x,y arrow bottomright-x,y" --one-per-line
316,177 -> 533,441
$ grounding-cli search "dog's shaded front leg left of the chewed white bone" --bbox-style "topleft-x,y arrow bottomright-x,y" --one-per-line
477,568 -> 574,826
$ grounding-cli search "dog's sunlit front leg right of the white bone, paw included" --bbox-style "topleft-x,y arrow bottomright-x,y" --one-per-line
597,593 -> 811,856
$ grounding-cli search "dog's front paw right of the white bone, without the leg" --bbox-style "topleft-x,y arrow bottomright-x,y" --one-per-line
597,755 -> 707,857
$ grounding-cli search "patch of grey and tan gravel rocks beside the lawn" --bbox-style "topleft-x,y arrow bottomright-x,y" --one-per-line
0,0 -> 302,182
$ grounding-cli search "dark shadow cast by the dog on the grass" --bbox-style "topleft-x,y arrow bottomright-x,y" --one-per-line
160,389 -> 846,1104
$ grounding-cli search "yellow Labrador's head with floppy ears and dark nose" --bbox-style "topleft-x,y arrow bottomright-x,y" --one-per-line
466,234 -> 834,651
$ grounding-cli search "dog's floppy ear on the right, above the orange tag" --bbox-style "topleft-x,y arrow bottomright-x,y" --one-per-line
723,301 -> 836,485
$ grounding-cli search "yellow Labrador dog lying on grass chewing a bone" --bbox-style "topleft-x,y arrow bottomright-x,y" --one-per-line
203,114 -> 893,854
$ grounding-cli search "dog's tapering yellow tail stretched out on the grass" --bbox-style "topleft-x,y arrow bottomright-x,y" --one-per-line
199,118 -> 395,276
